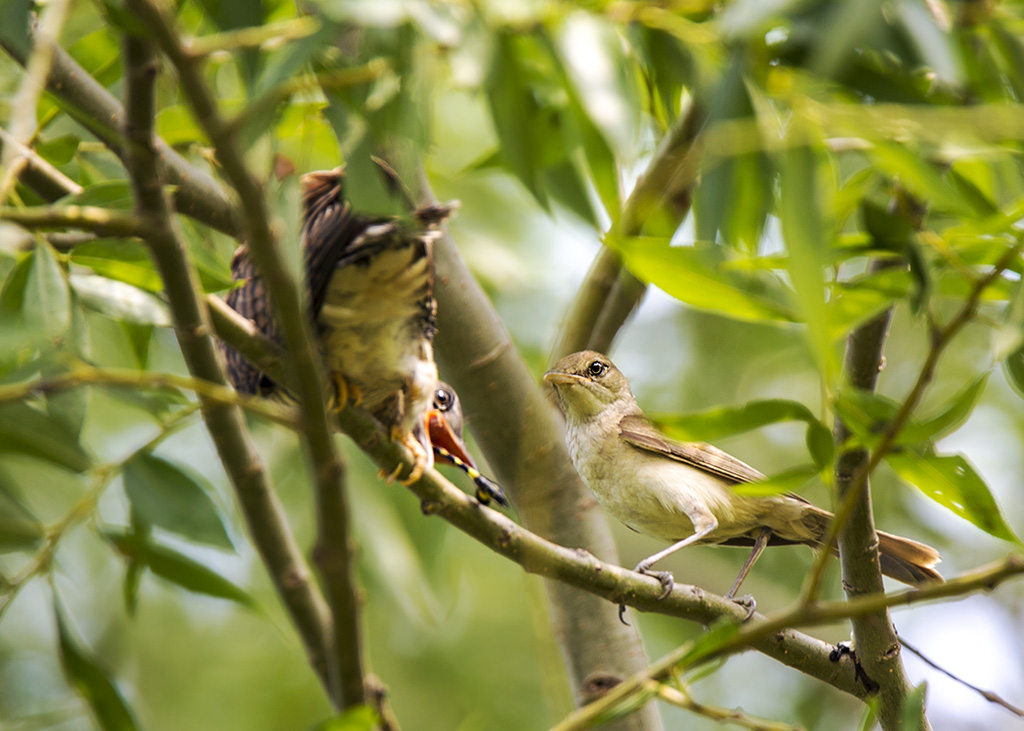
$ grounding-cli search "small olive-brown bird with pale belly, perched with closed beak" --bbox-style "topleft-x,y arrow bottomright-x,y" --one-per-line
544,350 -> 943,616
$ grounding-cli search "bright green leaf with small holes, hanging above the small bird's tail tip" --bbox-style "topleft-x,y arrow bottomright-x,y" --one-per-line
886,452 -> 1021,544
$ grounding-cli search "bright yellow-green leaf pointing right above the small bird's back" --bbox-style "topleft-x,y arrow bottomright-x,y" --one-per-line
605,235 -> 794,321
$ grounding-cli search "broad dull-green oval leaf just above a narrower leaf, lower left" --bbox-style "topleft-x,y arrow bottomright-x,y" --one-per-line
124,452 -> 233,549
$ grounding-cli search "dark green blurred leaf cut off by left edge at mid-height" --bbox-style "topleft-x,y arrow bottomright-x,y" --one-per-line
0,401 -> 92,472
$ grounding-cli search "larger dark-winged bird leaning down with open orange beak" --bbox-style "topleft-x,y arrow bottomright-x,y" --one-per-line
224,168 -> 506,505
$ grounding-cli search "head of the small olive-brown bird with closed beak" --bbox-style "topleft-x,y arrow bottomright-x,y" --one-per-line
544,350 -> 636,421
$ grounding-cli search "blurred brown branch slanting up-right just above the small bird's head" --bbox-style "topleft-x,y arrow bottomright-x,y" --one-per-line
552,102 -> 703,362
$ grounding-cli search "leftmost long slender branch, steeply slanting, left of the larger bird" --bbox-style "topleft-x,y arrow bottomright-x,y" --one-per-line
119,27 -> 331,700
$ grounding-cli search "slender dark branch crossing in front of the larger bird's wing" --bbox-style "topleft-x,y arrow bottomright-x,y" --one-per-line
129,0 -> 366,708
